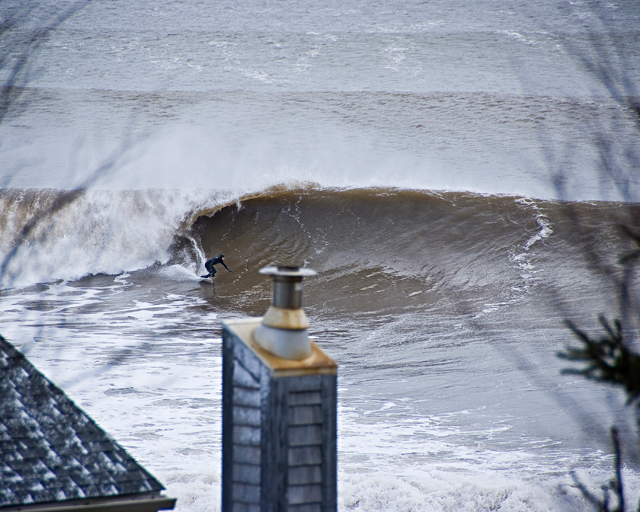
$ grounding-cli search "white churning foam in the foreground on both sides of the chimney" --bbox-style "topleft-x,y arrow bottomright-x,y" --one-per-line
7,318 -> 638,512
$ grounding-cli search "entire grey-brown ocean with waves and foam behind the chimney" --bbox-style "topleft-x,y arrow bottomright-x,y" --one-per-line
0,0 -> 640,512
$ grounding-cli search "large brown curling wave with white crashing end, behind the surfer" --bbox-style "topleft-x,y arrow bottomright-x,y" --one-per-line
0,184 -> 631,318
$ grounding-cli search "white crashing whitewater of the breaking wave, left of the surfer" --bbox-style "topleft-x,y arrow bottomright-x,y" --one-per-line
0,190 -> 235,288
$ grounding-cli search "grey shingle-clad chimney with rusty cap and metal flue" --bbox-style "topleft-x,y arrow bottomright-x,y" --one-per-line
222,267 -> 337,512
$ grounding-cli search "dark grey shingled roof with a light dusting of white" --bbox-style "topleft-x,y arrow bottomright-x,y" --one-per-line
0,336 -> 175,512
